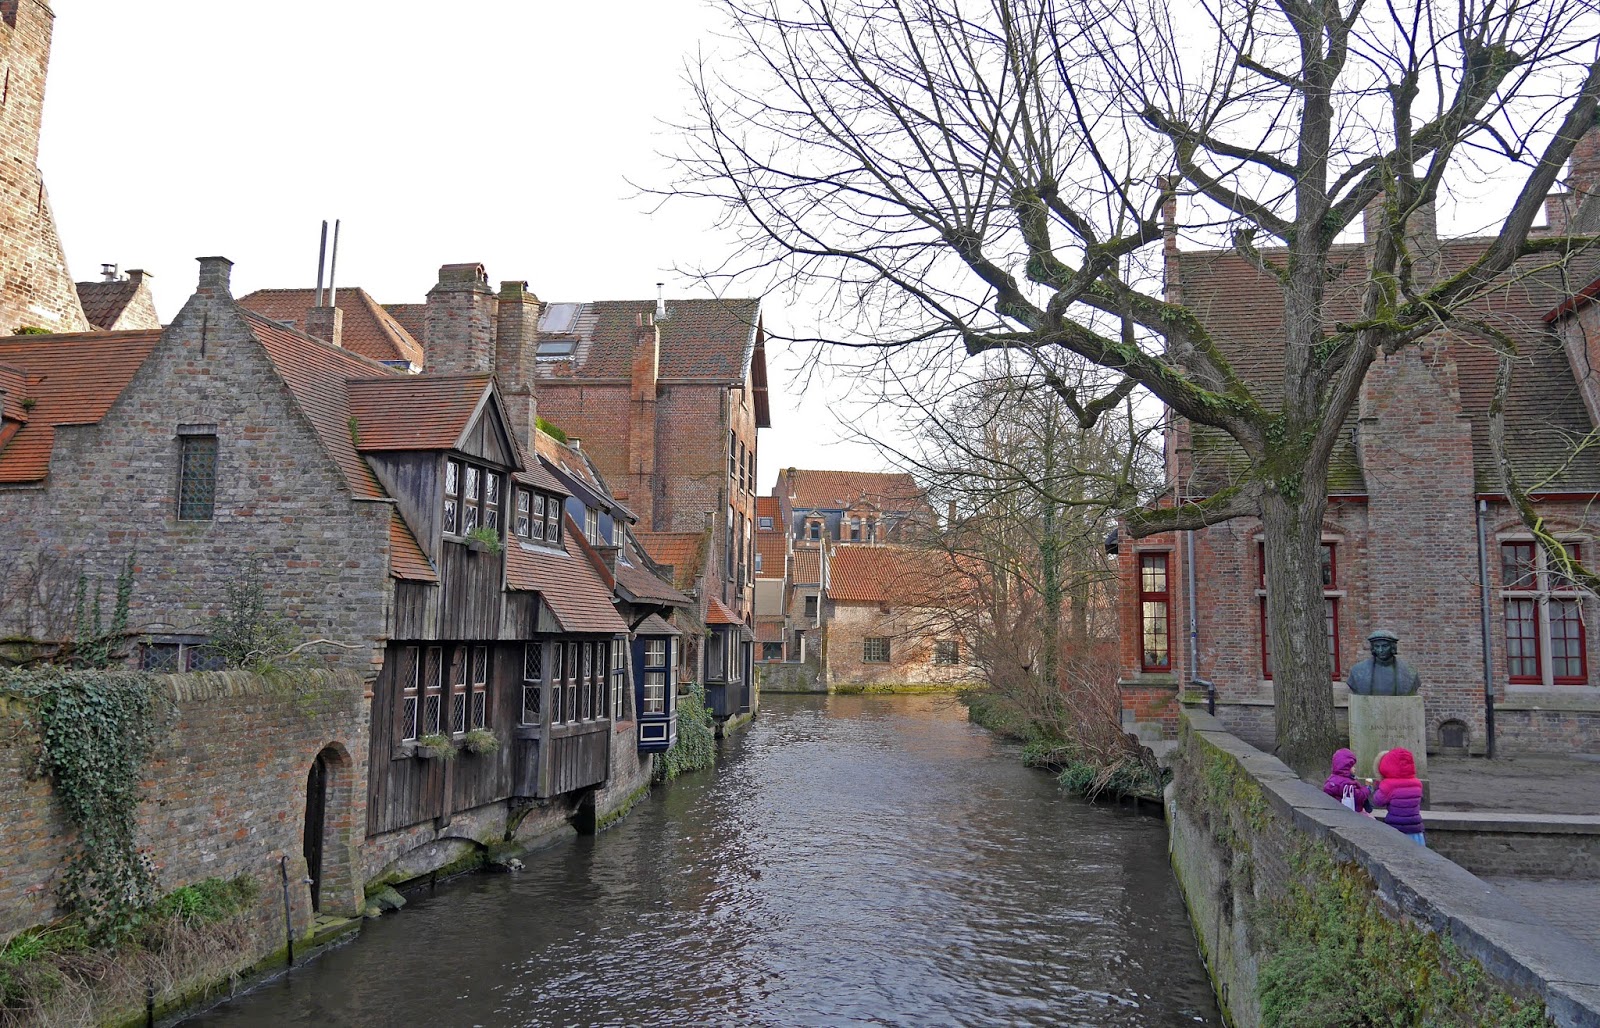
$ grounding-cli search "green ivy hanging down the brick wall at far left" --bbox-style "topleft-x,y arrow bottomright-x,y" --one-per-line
0,666 -> 157,942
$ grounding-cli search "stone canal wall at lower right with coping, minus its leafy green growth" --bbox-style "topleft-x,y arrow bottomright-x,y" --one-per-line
1166,709 -> 1600,1028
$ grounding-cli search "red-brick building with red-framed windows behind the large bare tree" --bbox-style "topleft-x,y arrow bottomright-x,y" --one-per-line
1117,176 -> 1600,753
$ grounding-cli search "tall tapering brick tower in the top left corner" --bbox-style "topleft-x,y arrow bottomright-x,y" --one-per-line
0,0 -> 90,335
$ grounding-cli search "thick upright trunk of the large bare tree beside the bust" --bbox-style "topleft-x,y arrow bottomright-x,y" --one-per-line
1261,489 -> 1341,778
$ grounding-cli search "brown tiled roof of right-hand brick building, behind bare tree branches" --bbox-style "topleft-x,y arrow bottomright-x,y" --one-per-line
1176,239 -> 1600,495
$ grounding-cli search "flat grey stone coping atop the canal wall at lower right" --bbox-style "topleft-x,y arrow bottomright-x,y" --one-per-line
1181,709 -> 1600,1028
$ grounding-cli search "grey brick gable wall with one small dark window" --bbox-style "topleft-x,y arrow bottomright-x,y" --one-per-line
0,280 -> 394,673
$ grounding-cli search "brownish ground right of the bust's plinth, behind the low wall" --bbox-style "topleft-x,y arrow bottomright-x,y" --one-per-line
1427,756 -> 1600,813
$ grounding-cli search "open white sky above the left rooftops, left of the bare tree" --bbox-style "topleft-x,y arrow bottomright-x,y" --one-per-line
40,0 -> 882,480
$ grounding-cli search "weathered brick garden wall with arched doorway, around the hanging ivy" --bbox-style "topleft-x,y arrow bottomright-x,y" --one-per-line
0,669 -> 368,935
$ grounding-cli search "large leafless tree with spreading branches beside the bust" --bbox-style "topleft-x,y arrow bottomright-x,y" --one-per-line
675,0 -> 1600,770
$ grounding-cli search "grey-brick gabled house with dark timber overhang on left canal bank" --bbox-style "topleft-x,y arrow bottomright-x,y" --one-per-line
0,258 -> 686,913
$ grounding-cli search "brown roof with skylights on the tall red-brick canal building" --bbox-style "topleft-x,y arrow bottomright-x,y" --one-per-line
539,299 -> 762,383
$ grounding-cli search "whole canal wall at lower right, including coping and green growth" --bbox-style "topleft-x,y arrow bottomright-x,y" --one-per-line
1166,709 -> 1600,1028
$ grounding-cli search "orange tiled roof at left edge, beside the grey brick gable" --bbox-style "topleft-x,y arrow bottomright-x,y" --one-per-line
0,330 -> 162,482
